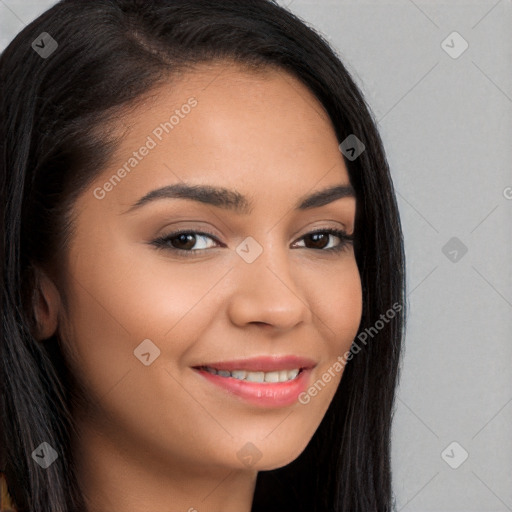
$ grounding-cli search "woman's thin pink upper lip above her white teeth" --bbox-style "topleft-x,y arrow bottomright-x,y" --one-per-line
194,355 -> 316,372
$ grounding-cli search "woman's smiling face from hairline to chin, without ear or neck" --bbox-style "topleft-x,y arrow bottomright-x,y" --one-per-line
53,63 -> 362,471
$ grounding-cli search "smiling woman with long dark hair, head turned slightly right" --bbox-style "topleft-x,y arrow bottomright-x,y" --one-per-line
0,0 -> 405,512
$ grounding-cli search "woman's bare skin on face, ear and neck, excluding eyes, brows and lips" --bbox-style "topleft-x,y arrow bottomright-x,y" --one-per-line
36,62 -> 362,512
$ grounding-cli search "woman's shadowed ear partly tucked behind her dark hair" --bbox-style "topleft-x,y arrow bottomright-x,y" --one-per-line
33,269 -> 61,341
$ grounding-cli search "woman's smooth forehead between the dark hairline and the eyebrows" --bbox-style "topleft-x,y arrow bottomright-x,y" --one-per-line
84,63 -> 349,215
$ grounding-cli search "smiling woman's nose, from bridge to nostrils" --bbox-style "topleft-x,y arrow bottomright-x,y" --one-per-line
228,241 -> 312,331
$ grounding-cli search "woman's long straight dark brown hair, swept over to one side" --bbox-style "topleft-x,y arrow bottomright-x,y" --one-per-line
0,0 -> 405,512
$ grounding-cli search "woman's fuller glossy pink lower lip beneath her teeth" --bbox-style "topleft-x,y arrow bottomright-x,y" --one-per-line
196,369 -> 311,408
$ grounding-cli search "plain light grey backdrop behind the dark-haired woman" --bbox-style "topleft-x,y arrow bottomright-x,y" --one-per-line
0,0 -> 512,512
